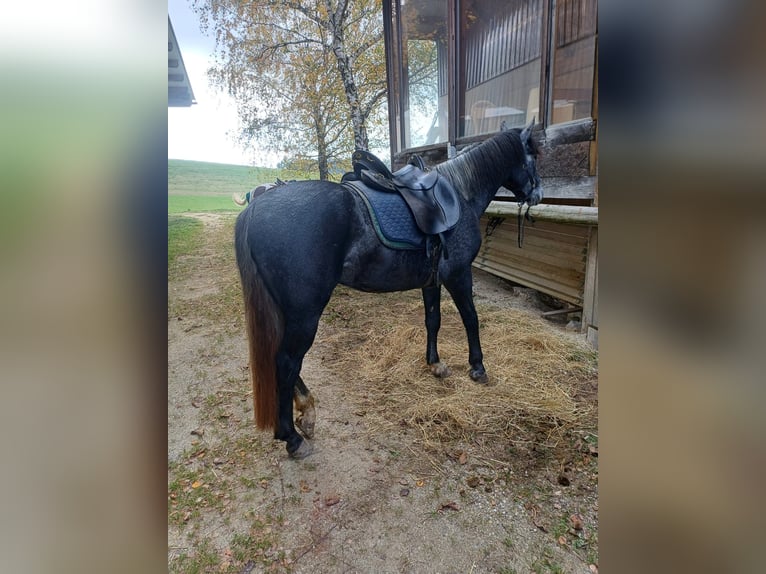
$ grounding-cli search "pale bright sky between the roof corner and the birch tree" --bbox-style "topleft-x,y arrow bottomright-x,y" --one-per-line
168,0 -> 279,167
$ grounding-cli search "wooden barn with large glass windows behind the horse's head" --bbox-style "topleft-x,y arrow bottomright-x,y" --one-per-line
383,0 -> 598,346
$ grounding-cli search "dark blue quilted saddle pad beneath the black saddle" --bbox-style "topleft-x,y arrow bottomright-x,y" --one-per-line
342,181 -> 426,249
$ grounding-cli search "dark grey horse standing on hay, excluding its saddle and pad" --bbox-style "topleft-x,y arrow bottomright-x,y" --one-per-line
234,121 -> 543,459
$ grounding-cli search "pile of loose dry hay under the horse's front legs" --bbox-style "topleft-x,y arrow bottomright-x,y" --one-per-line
325,290 -> 597,445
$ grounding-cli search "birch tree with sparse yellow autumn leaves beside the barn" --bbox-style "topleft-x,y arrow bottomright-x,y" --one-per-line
194,0 -> 386,179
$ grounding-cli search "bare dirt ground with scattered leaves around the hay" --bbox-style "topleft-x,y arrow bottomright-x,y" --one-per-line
168,215 -> 598,574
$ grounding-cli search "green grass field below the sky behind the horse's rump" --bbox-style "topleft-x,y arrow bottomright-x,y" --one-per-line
168,159 -> 318,214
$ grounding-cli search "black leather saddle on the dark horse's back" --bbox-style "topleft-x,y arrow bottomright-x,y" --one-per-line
341,150 -> 460,235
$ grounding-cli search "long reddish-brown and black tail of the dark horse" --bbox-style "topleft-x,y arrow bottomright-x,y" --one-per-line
234,209 -> 284,429
